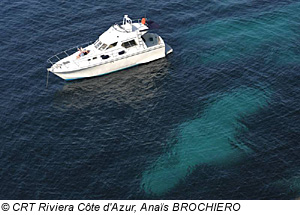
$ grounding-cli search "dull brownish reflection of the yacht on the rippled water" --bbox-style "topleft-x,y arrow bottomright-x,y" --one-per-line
53,58 -> 169,110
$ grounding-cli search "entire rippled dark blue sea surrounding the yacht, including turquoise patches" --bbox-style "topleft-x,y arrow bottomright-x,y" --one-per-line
0,0 -> 300,199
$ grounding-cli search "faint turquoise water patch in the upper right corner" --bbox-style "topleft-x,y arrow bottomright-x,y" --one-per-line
183,3 -> 300,64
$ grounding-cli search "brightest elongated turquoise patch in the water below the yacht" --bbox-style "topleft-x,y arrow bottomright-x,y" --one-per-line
141,88 -> 270,195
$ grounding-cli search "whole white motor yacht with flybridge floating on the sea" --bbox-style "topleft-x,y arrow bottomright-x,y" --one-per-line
48,15 -> 173,80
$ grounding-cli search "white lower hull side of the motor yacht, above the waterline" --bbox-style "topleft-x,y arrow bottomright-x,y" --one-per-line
53,44 -> 173,81
